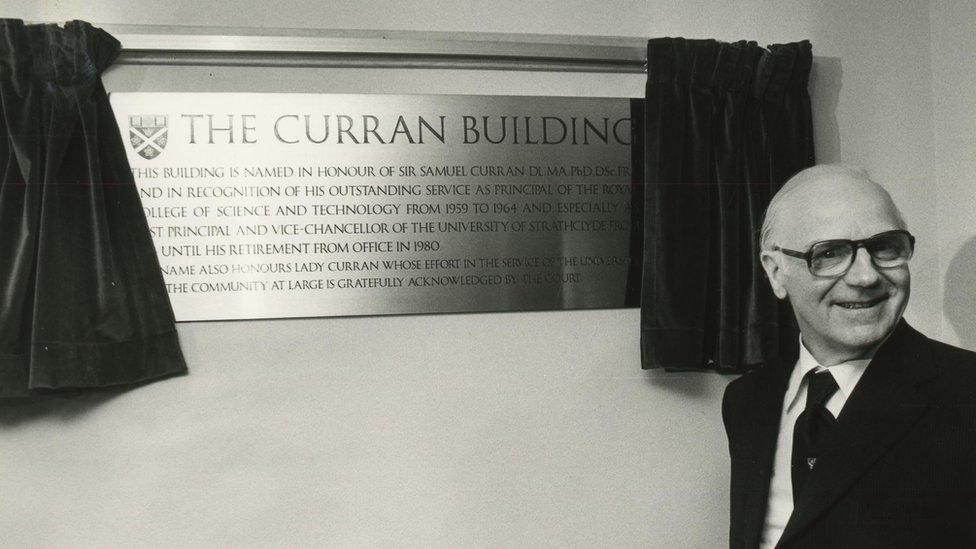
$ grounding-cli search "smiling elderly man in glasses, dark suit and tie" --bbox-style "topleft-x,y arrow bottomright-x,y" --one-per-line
722,166 -> 976,548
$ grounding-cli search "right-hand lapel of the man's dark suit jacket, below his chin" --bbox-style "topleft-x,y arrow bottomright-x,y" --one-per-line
780,320 -> 936,544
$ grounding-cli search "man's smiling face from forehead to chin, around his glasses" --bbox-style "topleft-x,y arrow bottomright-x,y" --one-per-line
762,181 -> 911,366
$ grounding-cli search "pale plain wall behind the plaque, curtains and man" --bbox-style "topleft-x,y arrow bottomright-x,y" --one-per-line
0,0 -> 960,547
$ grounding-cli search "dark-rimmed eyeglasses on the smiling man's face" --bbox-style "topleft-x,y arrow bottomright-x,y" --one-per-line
773,230 -> 915,277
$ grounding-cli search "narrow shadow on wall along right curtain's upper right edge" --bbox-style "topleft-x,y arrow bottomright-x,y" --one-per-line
809,57 -> 844,164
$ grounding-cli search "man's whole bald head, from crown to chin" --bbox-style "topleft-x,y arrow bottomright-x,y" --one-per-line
759,166 -> 911,366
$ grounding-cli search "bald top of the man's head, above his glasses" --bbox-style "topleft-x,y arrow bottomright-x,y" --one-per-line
760,164 -> 907,250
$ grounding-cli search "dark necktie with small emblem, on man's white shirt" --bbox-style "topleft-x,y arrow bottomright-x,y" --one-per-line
792,370 -> 837,501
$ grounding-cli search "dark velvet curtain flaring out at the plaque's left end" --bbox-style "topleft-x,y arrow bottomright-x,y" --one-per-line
0,20 -> 186,397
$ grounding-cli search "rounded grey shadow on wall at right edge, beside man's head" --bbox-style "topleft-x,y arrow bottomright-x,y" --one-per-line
942,236 -> 976,350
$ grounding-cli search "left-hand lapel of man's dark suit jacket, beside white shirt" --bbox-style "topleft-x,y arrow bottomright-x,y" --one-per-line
732,348 -> 796,547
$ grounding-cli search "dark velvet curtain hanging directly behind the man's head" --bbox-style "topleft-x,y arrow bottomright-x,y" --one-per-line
641,38 -> 814,373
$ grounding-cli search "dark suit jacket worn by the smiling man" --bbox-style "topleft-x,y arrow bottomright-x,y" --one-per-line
722,320 -> 976,548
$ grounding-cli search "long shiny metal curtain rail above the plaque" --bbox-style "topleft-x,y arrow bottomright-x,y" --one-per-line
89,25 -> 646,73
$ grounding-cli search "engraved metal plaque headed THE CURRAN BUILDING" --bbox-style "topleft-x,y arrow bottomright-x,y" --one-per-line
111,93 -> 632,321
